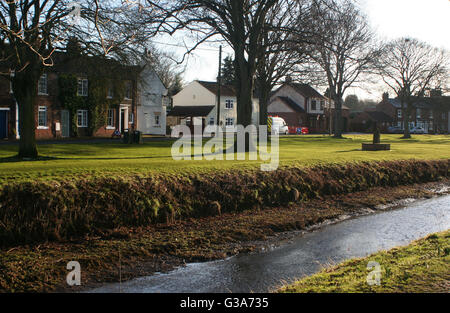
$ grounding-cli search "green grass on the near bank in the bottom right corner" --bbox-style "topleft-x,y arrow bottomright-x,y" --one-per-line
279,230 -> 450,293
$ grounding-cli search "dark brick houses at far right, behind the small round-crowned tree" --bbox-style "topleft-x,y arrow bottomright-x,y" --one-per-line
377,91 -> 450,134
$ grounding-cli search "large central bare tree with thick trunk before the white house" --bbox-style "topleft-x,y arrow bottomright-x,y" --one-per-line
147,0 -> 296,126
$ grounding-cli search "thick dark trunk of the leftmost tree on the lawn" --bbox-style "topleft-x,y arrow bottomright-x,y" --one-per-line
13,69 -> 39,159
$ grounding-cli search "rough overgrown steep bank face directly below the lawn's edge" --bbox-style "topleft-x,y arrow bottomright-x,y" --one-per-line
0,160 -> 450,247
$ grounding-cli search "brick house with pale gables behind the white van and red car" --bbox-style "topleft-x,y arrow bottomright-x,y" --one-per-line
267,82 -> 350,133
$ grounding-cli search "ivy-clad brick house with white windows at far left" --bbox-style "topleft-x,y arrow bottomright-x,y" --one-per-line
0,53 -> 139,139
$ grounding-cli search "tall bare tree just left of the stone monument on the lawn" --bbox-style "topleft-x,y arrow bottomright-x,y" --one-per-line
298,0 -> 379,138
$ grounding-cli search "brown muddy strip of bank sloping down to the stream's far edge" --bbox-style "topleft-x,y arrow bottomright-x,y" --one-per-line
0,180 -> 450,292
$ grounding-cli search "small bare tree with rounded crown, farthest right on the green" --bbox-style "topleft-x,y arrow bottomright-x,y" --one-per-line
376,38 -> 448,138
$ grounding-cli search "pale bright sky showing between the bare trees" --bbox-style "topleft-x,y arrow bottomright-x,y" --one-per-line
155,0 -> 450,100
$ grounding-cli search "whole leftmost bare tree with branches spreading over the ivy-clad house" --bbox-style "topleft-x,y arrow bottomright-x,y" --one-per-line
0,0 -> 154,158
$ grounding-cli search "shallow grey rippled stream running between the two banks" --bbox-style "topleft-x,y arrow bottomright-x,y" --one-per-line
90,195 -> 450,293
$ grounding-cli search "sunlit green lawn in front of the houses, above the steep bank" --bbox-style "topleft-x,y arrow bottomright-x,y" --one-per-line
0,135 -> 450,184
